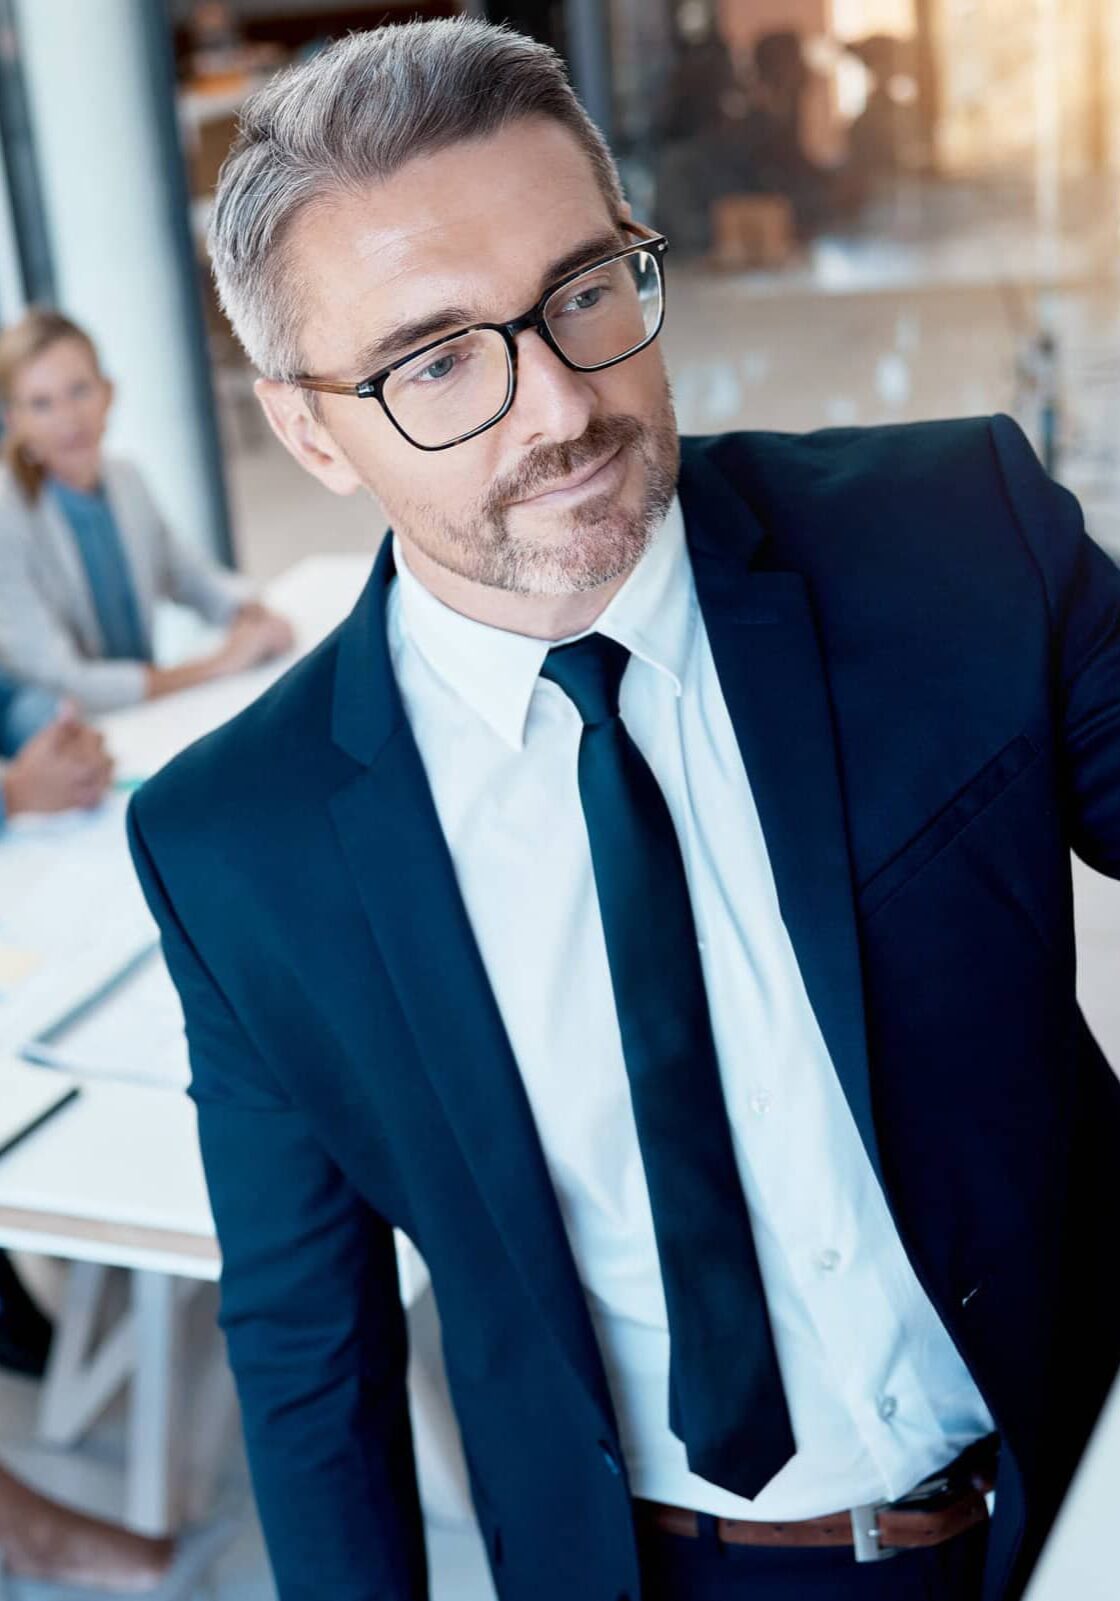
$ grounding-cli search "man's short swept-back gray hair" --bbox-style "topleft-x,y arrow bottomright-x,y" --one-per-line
210,18 -> 622,381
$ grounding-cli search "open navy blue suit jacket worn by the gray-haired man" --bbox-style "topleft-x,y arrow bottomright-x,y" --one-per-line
131,419 -> 1120,1601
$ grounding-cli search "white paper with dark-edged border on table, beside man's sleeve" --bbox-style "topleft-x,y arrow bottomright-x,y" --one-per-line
22,951 -> 190,1089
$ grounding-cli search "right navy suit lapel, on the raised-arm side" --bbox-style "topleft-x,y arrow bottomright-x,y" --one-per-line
680,448 -> 882,1182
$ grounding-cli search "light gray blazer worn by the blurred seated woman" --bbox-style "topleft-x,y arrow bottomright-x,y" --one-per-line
0,459 -> 251,714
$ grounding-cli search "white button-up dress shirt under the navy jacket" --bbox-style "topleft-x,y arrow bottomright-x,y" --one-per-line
387,503 -> 994,1519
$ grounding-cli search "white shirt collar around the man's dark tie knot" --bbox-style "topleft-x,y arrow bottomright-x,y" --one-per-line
394,498 -> 696,751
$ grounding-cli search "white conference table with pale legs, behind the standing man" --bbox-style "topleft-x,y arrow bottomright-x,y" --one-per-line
0,556 -> 380,1534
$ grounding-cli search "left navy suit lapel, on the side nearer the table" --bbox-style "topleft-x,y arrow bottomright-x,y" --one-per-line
331,540 -> 610,1417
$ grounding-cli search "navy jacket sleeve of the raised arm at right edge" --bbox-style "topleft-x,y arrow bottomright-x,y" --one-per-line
992,418 -> 1120,879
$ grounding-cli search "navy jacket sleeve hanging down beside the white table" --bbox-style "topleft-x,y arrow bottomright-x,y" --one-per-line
130,796 -> 427,1601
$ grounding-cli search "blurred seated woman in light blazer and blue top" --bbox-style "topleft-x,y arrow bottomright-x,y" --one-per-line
0,309 -> 293,712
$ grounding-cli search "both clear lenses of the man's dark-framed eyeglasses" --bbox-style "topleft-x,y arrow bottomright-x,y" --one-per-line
382,250 -> 661,448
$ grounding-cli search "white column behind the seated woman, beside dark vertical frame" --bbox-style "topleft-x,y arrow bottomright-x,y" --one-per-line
16,0 -> 225,563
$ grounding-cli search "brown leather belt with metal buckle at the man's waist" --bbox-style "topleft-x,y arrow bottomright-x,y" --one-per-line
634,1463 -> 995,1561
